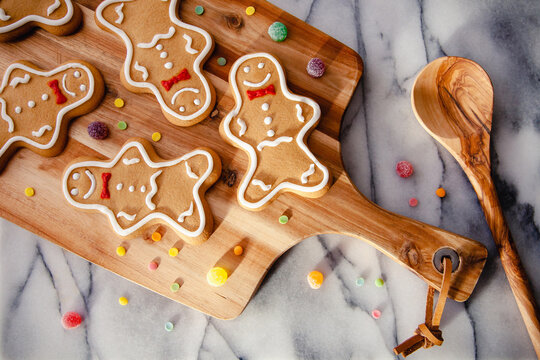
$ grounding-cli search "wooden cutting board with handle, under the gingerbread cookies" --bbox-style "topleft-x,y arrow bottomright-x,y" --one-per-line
0,0 -> 487,319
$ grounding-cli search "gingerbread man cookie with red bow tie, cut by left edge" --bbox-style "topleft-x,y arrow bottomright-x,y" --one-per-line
0,60 -> 104,171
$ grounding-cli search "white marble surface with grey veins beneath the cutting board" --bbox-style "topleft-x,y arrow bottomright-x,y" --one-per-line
0,0 -> 540,359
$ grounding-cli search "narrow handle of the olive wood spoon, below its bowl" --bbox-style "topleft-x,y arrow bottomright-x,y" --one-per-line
466,167 -> 540,358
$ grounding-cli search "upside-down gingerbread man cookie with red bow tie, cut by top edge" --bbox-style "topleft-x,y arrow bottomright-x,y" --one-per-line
96,0 -> 215,126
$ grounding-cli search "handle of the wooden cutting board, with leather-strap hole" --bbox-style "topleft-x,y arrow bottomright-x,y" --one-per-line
318,172 -> 487,301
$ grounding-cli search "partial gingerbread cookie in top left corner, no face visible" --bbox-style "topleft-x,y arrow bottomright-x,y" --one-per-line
0,0 -> 82,41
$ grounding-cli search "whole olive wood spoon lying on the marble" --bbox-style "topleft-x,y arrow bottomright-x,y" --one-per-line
411,57 -> 540,358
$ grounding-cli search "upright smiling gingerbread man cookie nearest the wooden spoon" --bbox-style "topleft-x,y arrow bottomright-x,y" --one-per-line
220,53 -> 331,210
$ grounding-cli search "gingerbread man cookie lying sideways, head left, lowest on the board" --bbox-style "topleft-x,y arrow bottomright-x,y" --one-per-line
62,139 -> 221,244
